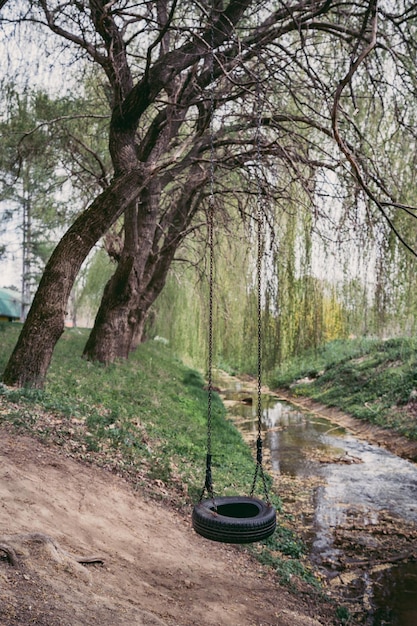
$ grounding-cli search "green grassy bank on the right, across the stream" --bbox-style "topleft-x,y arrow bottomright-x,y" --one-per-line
268,338 -> 417,440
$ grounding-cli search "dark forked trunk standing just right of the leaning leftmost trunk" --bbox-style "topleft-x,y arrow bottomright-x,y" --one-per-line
83,166 -> 208,364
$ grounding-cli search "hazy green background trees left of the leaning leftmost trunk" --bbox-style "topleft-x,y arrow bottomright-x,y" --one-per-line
0,79 -> 111,320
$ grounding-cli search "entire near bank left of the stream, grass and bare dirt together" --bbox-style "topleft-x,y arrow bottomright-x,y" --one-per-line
0,325 -> 343,626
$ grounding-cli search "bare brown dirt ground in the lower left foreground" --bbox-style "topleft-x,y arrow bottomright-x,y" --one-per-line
0,426 -> 335,626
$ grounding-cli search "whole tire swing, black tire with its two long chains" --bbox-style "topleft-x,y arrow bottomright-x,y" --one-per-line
192,15 -> 276,544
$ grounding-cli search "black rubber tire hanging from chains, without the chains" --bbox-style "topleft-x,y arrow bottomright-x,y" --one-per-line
192,496 -> 277,543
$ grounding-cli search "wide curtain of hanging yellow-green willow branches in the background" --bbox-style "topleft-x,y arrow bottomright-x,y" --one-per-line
151,161 -> 417,373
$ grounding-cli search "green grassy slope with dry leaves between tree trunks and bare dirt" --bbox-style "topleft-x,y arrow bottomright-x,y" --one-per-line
0,324 -> 316,584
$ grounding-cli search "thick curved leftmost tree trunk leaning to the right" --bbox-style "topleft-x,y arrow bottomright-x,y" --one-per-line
3,170 -> 143,387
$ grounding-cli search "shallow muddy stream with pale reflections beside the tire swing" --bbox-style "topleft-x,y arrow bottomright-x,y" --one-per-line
220,381 -> 417,626
